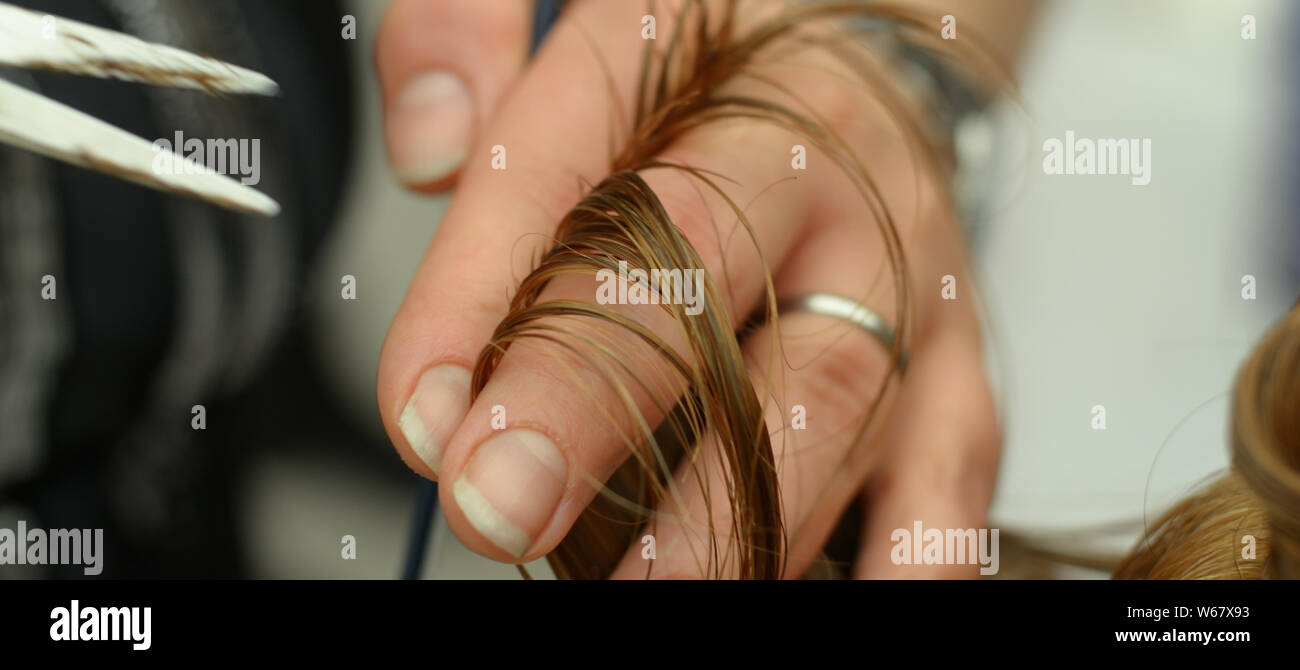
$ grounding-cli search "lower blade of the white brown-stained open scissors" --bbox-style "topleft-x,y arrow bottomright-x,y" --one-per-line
0,79 -> 280,216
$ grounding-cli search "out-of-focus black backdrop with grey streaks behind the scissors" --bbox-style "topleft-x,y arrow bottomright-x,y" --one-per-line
0,0 -> 354,578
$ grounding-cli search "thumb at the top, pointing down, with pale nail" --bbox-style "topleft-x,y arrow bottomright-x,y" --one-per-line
374,0 -> 533,191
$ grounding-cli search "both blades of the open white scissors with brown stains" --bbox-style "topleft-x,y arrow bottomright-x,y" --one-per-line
0,3 -> 280,216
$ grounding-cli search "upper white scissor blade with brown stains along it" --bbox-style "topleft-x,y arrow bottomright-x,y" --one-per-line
0,3 -> 280,95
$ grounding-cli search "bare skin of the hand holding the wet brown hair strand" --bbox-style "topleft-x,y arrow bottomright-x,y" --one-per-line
376,0 -> 1001,578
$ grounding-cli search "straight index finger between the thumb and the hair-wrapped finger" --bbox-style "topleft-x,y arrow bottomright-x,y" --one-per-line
377,3 -> 665,477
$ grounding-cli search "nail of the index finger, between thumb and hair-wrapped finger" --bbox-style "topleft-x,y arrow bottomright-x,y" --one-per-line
398,364 -> 471,474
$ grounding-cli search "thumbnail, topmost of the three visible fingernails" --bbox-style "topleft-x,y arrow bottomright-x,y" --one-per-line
386,72 -> 475,185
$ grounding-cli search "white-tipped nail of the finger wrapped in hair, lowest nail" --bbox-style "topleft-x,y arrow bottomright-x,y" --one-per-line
452,429 -> 567,558
